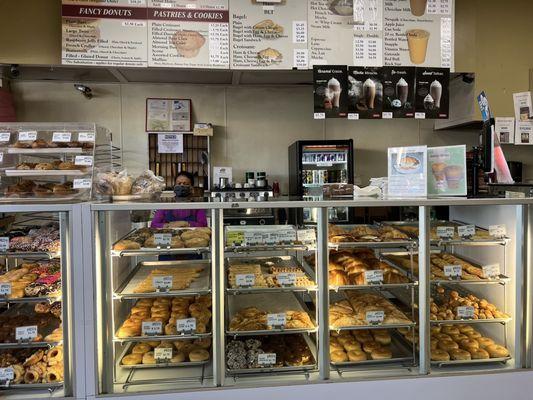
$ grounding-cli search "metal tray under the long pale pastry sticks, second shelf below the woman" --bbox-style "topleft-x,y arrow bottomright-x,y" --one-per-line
114,260 -> 211,299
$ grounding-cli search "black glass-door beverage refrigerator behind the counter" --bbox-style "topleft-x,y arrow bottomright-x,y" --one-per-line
289,139 -> 354,225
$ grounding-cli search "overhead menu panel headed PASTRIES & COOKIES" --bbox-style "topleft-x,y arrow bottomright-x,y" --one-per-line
147,0 -> 229,68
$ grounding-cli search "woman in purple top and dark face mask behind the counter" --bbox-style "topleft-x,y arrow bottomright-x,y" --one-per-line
150,171 -> 207,228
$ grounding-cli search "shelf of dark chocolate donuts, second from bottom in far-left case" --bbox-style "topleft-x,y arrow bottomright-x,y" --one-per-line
0,301 -> 63,348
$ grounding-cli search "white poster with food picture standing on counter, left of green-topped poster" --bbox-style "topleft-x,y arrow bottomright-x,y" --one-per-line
388,146 -> 427,197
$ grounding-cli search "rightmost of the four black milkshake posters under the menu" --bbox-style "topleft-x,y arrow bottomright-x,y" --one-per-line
415,68 -> 450,119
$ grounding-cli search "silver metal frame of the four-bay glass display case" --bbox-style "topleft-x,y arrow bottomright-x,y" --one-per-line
87,198 -> 533,397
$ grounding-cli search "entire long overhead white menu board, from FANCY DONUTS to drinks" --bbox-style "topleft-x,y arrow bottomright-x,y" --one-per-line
62,0 -> 455,69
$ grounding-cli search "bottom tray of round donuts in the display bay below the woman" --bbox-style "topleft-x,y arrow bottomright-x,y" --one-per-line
119,337 -> 211,369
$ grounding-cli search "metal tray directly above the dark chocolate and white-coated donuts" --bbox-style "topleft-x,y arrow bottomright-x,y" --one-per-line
225,292 -> 317,336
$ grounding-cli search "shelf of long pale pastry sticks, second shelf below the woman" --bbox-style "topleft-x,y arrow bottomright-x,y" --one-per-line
114,260 -> 211,299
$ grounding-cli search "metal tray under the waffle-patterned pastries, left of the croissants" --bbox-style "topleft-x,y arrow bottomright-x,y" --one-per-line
226,256 -> 317,294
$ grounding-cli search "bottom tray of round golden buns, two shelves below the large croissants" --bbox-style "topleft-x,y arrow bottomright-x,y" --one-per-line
329,328 -> 415,369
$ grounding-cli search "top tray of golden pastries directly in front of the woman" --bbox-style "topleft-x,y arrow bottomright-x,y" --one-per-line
112,228 -> 211,257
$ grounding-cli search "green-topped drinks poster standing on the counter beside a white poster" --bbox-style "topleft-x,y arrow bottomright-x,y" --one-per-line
428,145 -> 467,196
